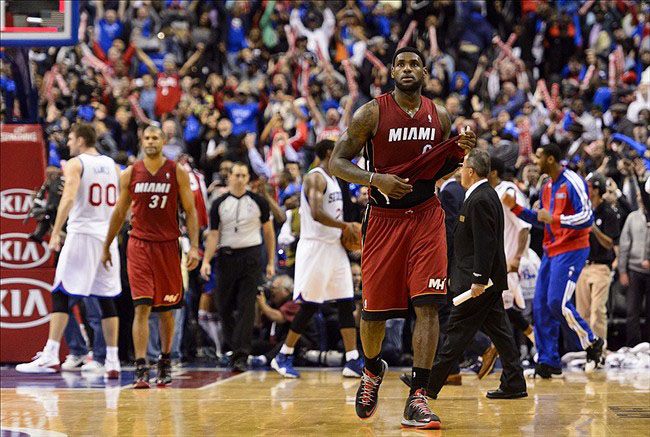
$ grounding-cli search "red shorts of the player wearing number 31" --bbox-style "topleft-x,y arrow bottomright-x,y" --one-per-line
126,237 -> 183,311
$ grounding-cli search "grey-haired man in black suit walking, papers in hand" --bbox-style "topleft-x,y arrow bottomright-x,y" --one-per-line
427,149 -> 527,399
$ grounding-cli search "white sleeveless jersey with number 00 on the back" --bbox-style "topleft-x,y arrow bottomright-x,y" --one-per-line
68,153 -> 119,240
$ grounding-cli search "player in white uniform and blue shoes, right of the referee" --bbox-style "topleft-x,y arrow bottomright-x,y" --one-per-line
271,140 -> 363,378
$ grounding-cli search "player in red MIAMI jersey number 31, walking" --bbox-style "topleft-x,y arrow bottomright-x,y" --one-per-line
102,126 -> 199,388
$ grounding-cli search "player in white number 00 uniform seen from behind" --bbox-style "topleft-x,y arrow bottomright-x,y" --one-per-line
16,124 -> 122,379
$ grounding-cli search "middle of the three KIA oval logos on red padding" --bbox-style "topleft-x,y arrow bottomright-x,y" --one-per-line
0,232 -> 50,269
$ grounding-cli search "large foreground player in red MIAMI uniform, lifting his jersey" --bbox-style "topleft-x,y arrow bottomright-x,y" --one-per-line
331,47 -> 476,429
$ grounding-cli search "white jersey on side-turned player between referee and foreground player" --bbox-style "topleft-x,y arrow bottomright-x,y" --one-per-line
300,167 -> 343,243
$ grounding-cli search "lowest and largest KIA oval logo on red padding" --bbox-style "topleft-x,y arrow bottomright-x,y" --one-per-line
0,278 -> 52,329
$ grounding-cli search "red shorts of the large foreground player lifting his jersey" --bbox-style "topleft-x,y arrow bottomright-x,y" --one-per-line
361,197 -> 447,320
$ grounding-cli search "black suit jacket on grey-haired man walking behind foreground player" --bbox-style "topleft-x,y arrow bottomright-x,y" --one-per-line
449,182 -> 508,294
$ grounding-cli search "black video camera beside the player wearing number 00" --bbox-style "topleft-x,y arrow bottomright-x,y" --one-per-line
23,168 -> 64,243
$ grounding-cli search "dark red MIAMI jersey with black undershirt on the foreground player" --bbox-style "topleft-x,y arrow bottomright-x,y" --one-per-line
364,93 -> 459,208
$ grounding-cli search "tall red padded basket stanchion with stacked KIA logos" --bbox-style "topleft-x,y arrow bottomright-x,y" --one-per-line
0,123 -> 55,363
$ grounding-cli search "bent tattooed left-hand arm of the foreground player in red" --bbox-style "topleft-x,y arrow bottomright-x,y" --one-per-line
330,99 -> 413,199
